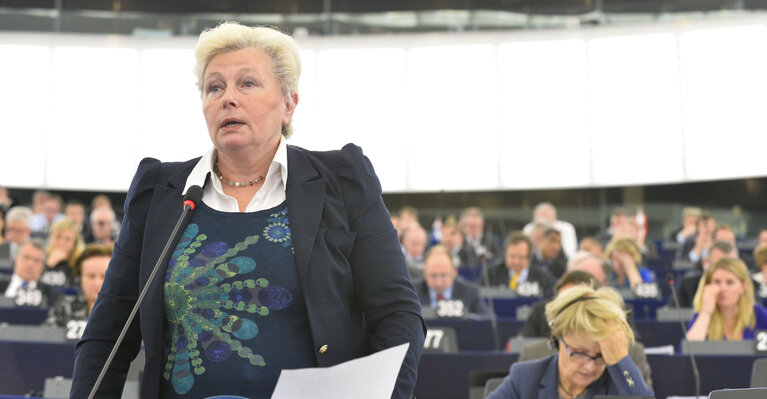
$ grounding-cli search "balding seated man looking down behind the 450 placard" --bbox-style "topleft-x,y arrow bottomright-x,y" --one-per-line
415,245 -> 488,316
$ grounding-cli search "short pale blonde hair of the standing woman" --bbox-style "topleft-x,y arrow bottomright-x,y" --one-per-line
194,21 -> 301,137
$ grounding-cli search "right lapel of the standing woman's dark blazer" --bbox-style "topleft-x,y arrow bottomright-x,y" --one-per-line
285,146 -> 325,292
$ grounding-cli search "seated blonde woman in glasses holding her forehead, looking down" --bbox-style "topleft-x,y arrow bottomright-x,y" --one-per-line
488,285 -> 653,399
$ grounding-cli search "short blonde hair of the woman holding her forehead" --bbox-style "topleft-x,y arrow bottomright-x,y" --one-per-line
546,285 -> 634,341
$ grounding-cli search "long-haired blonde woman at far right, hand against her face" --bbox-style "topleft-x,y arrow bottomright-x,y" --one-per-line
687,258 -> 767,341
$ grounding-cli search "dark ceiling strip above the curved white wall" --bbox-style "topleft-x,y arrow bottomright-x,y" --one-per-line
0,0 -> 767,36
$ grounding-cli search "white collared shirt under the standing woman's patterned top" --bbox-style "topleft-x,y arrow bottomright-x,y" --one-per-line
184,137 -> 288,212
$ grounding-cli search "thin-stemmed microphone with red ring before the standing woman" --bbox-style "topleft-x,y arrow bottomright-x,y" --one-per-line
88,185 -> 202,399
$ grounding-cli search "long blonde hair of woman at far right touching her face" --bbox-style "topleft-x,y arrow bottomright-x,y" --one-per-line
693,258 -> 756,341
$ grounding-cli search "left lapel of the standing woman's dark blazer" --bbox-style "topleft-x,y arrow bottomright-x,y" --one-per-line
139,163 -> 195,353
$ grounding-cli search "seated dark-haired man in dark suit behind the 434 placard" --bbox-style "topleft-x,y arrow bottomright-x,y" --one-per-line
487,232 -> 556,298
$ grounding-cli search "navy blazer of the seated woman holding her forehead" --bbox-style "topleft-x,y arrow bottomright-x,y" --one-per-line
487,355 -> 653,399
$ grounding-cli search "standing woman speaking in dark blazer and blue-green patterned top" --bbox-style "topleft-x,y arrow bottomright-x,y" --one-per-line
71,22 -> 425,398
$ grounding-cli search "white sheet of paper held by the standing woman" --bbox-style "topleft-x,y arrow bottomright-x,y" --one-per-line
272,343 -> 410,399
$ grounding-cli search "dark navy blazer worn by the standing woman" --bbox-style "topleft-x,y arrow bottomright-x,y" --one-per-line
71,144 -> 426,398
